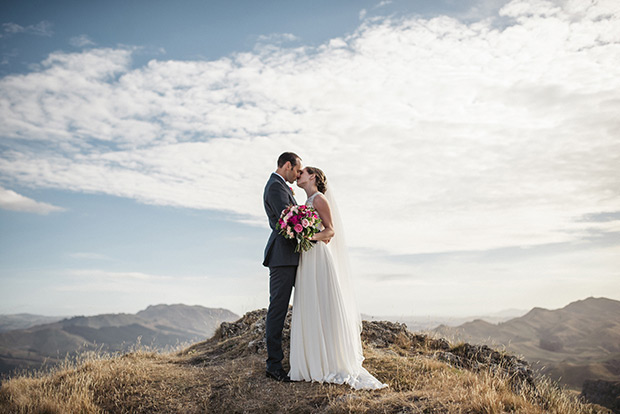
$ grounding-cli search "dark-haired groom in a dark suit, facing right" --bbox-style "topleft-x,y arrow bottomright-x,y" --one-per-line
263,152 -> 302,382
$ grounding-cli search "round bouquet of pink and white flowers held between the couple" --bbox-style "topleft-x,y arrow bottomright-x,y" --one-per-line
277,205 -> 321,252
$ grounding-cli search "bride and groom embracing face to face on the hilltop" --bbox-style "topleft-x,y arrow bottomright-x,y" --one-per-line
263,152 -> 387,389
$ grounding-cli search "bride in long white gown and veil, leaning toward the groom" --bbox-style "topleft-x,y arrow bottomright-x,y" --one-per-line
289,167 -> 387,389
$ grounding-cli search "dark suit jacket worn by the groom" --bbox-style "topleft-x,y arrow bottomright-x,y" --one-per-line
263,173 -> 299,267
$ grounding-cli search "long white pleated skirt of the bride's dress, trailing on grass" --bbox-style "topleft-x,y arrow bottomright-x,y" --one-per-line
289,242 -> 387,389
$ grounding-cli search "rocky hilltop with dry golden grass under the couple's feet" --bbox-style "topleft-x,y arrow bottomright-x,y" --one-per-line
0,309 -> 609,414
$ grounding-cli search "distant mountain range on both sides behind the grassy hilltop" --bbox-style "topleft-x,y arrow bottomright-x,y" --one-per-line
0,298 -> 620,396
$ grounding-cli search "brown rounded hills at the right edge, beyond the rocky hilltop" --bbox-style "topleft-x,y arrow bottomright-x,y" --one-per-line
435,298 -> 620,390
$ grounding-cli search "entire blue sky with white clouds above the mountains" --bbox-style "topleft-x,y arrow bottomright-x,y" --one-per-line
0,0 -> 620,316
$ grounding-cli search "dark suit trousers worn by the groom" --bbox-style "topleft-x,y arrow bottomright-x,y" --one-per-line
265,266 -> 297,372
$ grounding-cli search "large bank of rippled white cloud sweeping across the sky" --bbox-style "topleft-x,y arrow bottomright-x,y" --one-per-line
0,0 -> 620,254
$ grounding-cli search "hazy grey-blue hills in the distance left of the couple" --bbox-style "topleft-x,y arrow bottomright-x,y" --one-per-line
0,305 -> 238,375
